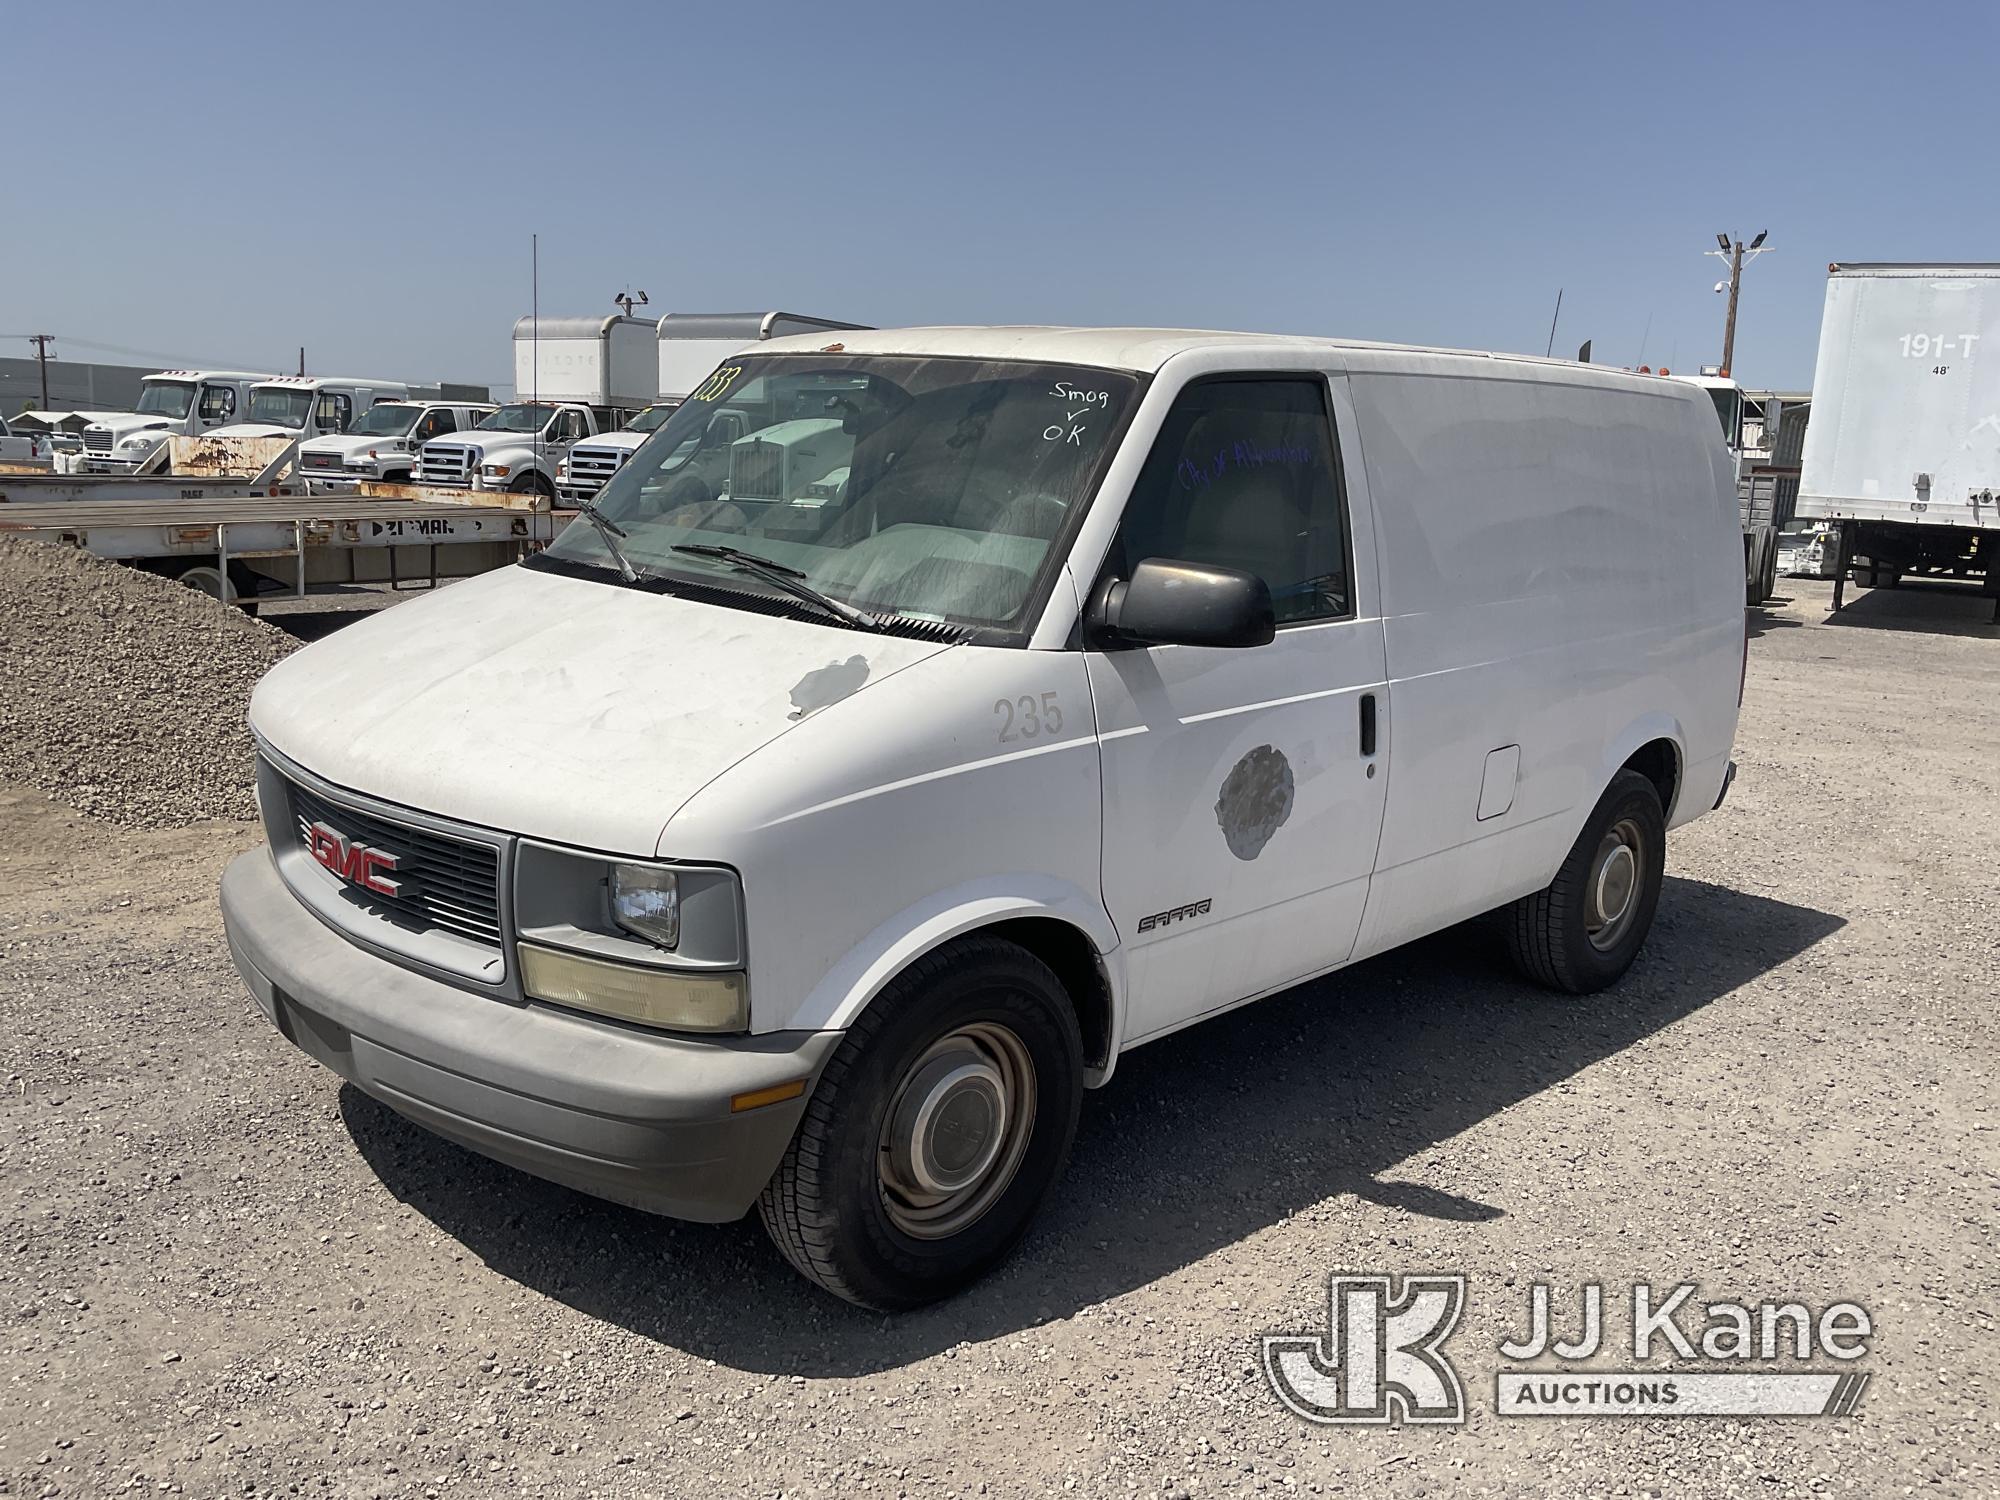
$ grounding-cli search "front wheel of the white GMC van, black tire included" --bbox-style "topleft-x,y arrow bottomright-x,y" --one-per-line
758,936 -> 1084,1312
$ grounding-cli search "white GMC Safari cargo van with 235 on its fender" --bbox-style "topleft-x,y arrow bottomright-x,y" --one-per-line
222,328 -> 1744,1308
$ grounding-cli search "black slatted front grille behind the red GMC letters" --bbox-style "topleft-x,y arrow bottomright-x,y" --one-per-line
292,782 -> 500,948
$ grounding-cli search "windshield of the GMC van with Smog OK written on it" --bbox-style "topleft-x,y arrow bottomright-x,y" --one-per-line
550,354 -> 1144,630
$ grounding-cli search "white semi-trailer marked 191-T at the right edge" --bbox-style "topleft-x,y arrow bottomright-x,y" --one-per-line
1798,262 -> 2000,620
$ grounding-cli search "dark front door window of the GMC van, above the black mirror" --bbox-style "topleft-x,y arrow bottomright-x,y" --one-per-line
1112,376 -> 1354,624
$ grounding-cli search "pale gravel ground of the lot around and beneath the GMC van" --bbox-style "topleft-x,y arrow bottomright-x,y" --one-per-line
0,582 -> 2000,1496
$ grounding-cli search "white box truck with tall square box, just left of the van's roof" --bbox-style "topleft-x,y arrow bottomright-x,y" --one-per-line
414,314 -> 654,498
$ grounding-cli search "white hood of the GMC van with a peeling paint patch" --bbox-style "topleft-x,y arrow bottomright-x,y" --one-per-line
250,566 -> 946,858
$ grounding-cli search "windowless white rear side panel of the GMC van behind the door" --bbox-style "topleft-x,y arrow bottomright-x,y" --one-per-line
1350,354 -> 1744,956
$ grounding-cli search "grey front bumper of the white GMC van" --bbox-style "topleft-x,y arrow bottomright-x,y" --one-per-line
222,848 -> 840,1222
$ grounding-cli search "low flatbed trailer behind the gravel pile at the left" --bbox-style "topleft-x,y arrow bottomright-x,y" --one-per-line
0,494 -> 568,606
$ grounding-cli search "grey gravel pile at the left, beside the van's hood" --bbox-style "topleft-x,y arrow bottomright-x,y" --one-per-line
0,538 -> 298,826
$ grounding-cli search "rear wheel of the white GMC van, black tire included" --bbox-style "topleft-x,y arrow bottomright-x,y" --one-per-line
1506,770 -> 1666,994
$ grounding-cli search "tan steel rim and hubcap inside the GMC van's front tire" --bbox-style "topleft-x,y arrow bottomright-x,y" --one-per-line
876,1022 -> 1034,1240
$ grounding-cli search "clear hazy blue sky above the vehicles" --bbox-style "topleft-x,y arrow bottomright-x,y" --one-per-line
0,0 -> 2000,386
